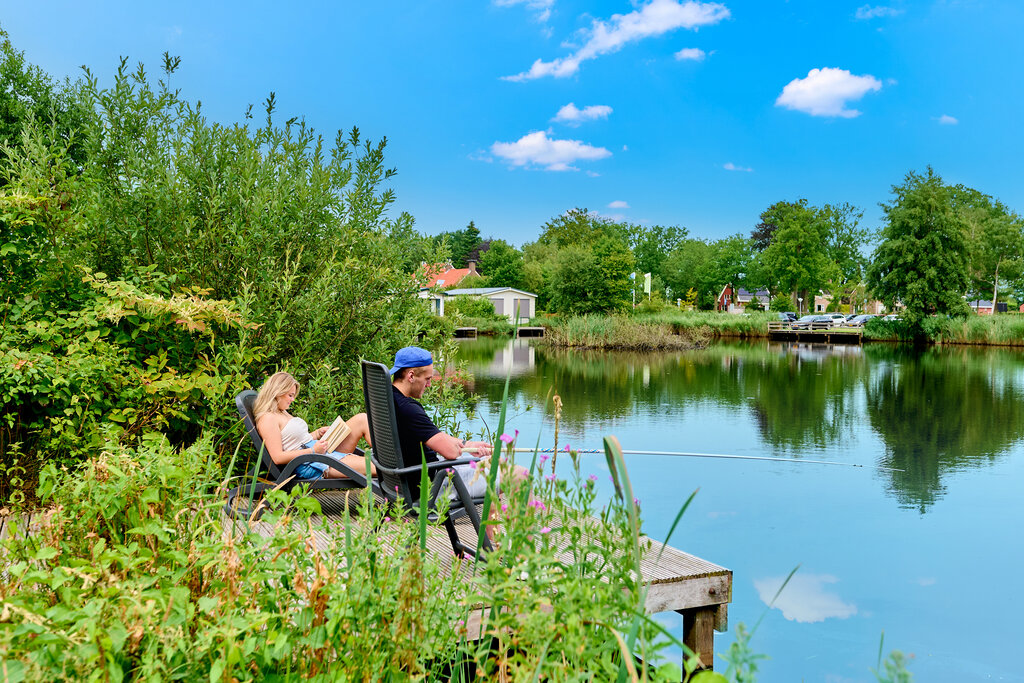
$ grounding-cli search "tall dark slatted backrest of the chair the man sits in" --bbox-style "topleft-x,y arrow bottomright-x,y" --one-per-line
361,360 -> 413,502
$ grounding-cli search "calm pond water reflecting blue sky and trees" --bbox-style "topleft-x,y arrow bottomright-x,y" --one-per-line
462,340 -> 1024,683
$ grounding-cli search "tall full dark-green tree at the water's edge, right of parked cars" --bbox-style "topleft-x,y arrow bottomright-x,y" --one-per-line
867,167 -> 969,334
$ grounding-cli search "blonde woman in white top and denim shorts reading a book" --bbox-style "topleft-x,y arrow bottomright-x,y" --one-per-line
253,373 -> 377,479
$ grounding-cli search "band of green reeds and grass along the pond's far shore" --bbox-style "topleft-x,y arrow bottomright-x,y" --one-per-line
463,311 -> 1024,351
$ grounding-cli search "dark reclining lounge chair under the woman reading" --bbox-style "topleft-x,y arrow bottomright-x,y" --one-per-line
224,389 -> 377,519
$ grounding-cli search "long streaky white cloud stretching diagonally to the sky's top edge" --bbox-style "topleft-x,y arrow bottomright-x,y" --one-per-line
504,0 -> 729,81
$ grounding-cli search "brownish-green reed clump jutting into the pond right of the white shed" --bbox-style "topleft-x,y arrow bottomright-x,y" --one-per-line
544,315 -> 711,351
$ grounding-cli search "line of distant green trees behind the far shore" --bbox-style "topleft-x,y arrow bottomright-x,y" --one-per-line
421,168 -> 1024,331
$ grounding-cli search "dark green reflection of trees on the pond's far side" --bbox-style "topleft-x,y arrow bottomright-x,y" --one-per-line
463,340 -> 1024,513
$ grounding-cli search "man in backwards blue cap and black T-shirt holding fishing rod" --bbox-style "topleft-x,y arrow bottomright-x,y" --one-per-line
390,346 -> 492,496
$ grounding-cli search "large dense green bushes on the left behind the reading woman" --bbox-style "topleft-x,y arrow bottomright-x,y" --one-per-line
0,47 -> 451,475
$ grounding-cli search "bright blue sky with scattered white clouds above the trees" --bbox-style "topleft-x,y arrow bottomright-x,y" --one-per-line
0,0 -> 1024,245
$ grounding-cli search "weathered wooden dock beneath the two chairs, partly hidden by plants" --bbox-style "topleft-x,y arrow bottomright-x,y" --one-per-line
0,490 -> 732,669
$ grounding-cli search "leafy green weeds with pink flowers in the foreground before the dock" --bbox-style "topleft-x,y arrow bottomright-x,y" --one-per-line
0,432 -> 679,681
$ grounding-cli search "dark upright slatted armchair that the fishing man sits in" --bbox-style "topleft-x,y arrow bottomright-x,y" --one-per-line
362,360 -> 492,557
